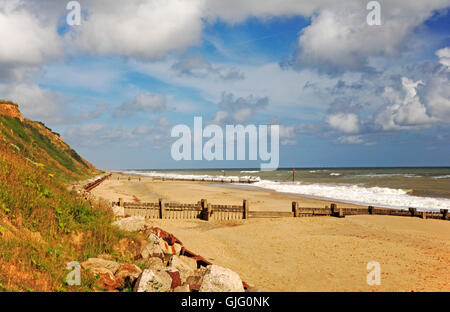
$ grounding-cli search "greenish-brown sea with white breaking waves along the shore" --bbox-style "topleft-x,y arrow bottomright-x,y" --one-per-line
121,167 -> 450,211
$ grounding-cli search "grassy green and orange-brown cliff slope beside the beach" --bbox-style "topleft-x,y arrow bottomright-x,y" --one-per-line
0,109 -> 137,291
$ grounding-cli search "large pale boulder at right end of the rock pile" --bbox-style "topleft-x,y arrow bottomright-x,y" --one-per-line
200,264 -> 244,292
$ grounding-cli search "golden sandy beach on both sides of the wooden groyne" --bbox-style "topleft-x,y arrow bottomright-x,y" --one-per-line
92,174 -> 450,291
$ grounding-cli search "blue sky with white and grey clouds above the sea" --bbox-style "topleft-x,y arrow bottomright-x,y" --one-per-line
0,0 -> 450,169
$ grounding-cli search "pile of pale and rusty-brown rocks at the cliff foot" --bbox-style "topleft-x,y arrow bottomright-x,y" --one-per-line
89,217 -> 245,292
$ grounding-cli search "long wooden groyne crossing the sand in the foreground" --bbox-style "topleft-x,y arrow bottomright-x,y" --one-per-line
117,198 -> 449,221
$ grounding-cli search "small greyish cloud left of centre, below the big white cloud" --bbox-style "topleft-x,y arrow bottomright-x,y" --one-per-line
114,92 -> 166,117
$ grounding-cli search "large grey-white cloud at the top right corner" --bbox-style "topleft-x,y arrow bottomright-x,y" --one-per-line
296,0 -> 449,73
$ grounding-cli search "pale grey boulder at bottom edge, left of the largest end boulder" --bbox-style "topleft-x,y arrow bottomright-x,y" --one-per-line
134,270 -> 172,292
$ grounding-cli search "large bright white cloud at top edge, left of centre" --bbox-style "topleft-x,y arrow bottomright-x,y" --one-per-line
67,0 -> 203,60
